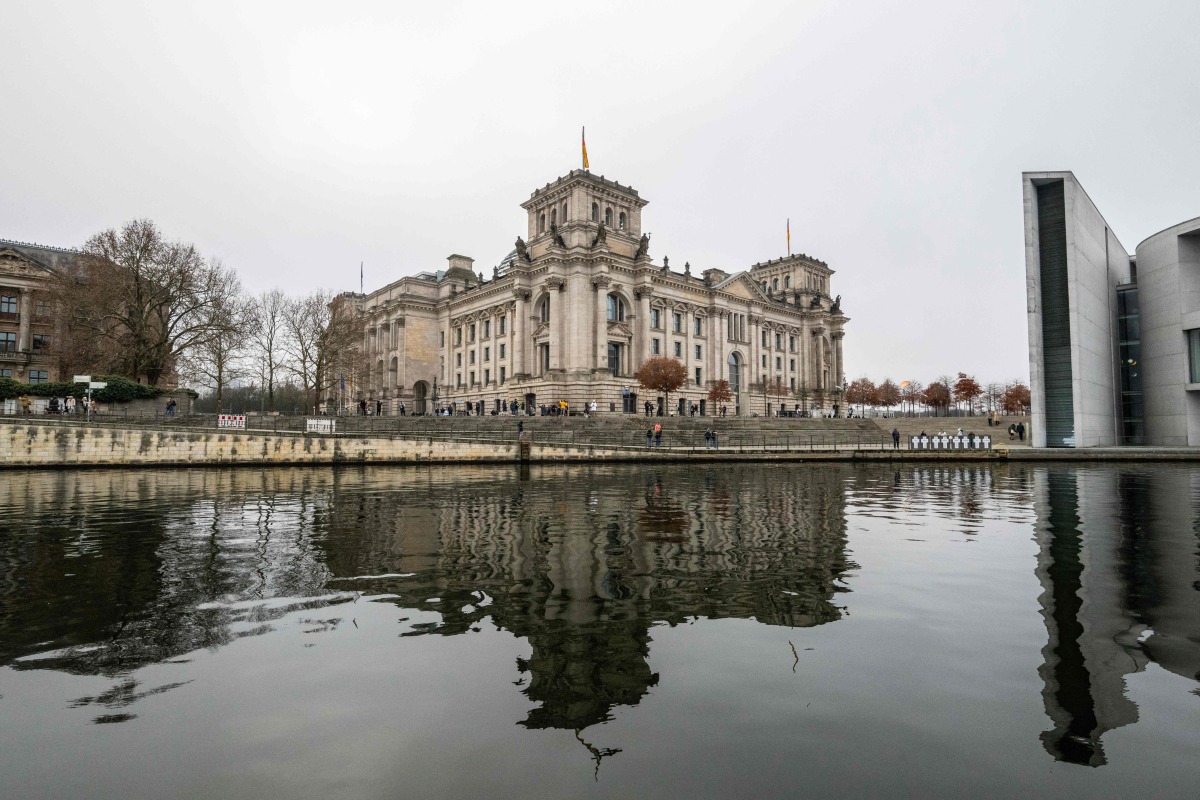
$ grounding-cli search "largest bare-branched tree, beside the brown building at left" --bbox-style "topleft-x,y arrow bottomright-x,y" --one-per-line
56,219 -> 241,385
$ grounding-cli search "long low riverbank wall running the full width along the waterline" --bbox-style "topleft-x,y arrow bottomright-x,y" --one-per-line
0,421 -> 1200,469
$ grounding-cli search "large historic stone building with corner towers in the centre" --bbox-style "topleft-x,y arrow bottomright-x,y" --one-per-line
326,169 -> 847,415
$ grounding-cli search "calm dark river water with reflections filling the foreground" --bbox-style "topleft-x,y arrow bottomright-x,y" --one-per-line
0,464 -> 1200,799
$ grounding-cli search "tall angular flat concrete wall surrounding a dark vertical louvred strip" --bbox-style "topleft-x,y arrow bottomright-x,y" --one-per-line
1022,172 -> 1129,447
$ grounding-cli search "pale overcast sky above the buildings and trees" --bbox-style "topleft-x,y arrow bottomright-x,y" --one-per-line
0,0 -> 1200,381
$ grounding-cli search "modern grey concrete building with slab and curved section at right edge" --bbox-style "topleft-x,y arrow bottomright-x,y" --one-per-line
1022,172 -> 1200,447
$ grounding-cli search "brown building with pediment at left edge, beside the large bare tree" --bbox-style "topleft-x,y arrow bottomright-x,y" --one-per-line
0,240 -> 78,384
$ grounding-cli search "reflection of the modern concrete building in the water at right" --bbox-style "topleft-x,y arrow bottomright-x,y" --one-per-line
1034,468 -> 1200,766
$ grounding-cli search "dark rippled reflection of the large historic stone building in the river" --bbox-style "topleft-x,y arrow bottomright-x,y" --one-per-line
330,467 -> 853,729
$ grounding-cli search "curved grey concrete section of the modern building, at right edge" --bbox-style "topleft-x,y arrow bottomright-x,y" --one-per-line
1138,219 -> 1200,446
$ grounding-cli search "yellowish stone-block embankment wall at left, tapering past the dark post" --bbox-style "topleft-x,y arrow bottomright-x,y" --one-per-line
0,423 -> 578,467
